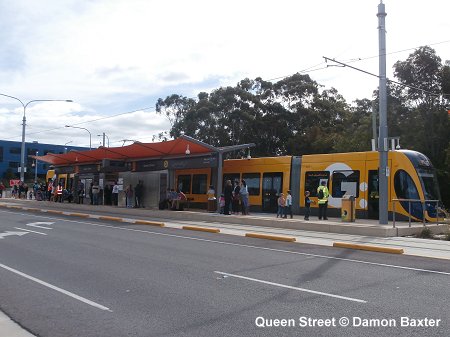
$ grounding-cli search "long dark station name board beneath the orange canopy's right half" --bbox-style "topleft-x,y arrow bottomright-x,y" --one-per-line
136,156 -> 217,171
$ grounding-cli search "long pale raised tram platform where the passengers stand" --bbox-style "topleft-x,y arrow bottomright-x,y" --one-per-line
0,198 -> 449,237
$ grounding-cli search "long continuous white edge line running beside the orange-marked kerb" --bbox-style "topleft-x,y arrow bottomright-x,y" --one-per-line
0,211 -> 450,276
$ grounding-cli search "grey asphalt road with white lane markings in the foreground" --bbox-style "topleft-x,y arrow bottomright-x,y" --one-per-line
0,210 -> 450,337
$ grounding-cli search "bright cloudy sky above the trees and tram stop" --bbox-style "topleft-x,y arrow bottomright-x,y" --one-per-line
0,0 -> 450,148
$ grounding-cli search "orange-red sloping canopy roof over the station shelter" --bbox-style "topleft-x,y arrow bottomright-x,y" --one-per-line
32,136 -> 217,166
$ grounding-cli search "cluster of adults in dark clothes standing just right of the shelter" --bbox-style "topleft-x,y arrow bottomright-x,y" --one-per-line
219,179 -> 249,215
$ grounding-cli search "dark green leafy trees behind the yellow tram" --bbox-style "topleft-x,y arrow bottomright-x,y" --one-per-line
156,46 -> 450,206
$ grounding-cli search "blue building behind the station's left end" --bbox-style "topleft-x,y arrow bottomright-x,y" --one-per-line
0,140 -> 89,180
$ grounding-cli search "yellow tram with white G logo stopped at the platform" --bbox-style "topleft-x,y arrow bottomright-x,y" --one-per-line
175,150 -> 440,221
